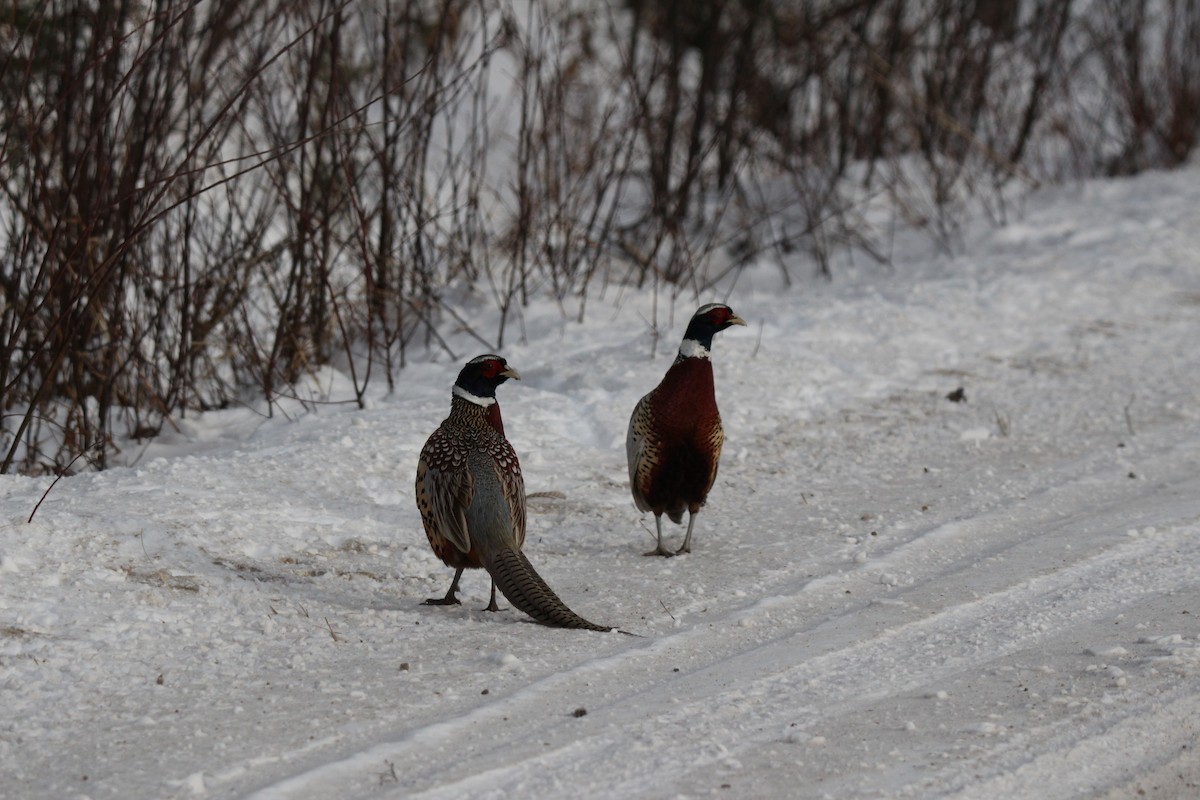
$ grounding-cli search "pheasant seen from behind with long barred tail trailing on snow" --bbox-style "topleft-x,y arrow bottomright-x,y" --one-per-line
416,355 -> 611,631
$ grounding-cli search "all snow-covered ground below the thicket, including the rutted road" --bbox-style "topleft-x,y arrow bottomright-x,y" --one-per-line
7,168 -> 1200,800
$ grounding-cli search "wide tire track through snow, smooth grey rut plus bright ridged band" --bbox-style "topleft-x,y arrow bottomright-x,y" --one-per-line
243,438 -> 1200,800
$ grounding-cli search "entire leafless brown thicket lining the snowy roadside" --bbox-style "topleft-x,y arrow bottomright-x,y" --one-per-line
0,0 -> 1200,473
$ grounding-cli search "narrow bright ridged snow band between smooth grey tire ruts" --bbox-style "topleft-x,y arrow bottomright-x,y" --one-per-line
397,522 -> 1200,798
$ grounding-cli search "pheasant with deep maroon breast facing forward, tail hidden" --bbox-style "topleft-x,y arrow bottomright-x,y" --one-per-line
625,302 -> 745,555
